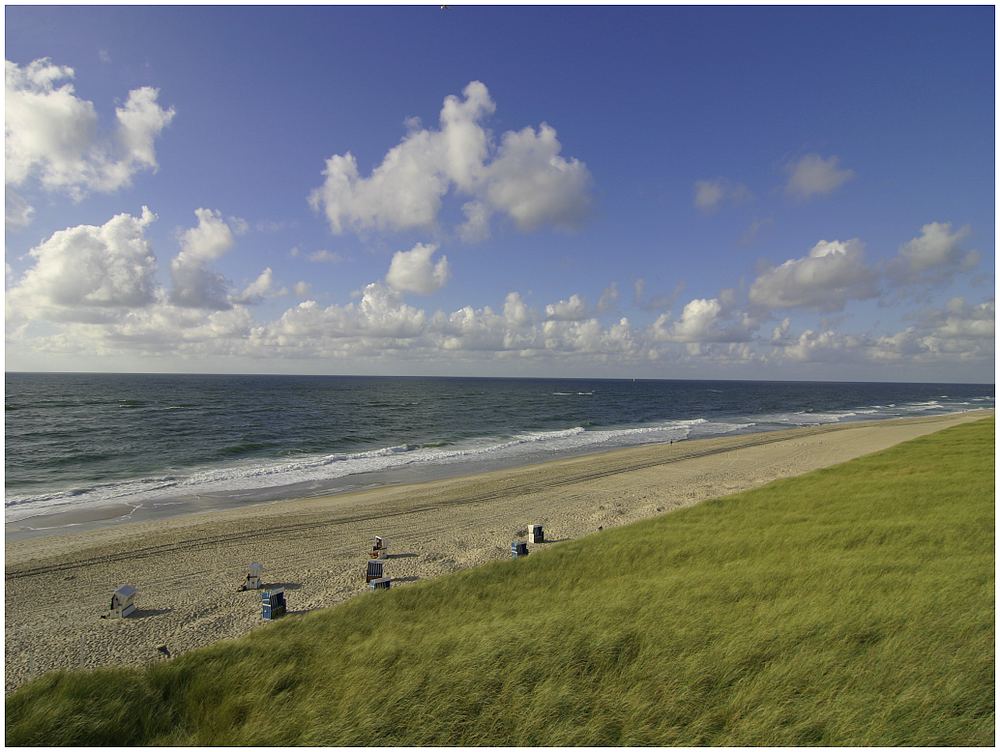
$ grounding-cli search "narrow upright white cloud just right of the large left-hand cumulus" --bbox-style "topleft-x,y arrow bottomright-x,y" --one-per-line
170,209 -> 235,310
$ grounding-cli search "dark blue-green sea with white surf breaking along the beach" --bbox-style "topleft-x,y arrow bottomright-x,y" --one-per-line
4,373 -> 994,523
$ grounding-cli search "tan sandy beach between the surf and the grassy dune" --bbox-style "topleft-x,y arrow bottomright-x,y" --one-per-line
5,411 -> 992,691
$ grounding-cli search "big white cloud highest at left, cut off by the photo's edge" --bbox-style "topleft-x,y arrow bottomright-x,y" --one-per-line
4,58 -> 174,200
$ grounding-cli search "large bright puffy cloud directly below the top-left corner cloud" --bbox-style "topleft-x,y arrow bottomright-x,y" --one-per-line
8,206 -> 156,321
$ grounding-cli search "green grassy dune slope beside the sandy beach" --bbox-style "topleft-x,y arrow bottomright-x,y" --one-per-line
7,419 -> 995,745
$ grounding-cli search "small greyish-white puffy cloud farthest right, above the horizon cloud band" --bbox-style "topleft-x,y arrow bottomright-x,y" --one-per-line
888,222 -> 979,284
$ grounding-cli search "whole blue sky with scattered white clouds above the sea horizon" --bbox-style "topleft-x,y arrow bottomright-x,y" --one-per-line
5,5 -> 995,383
